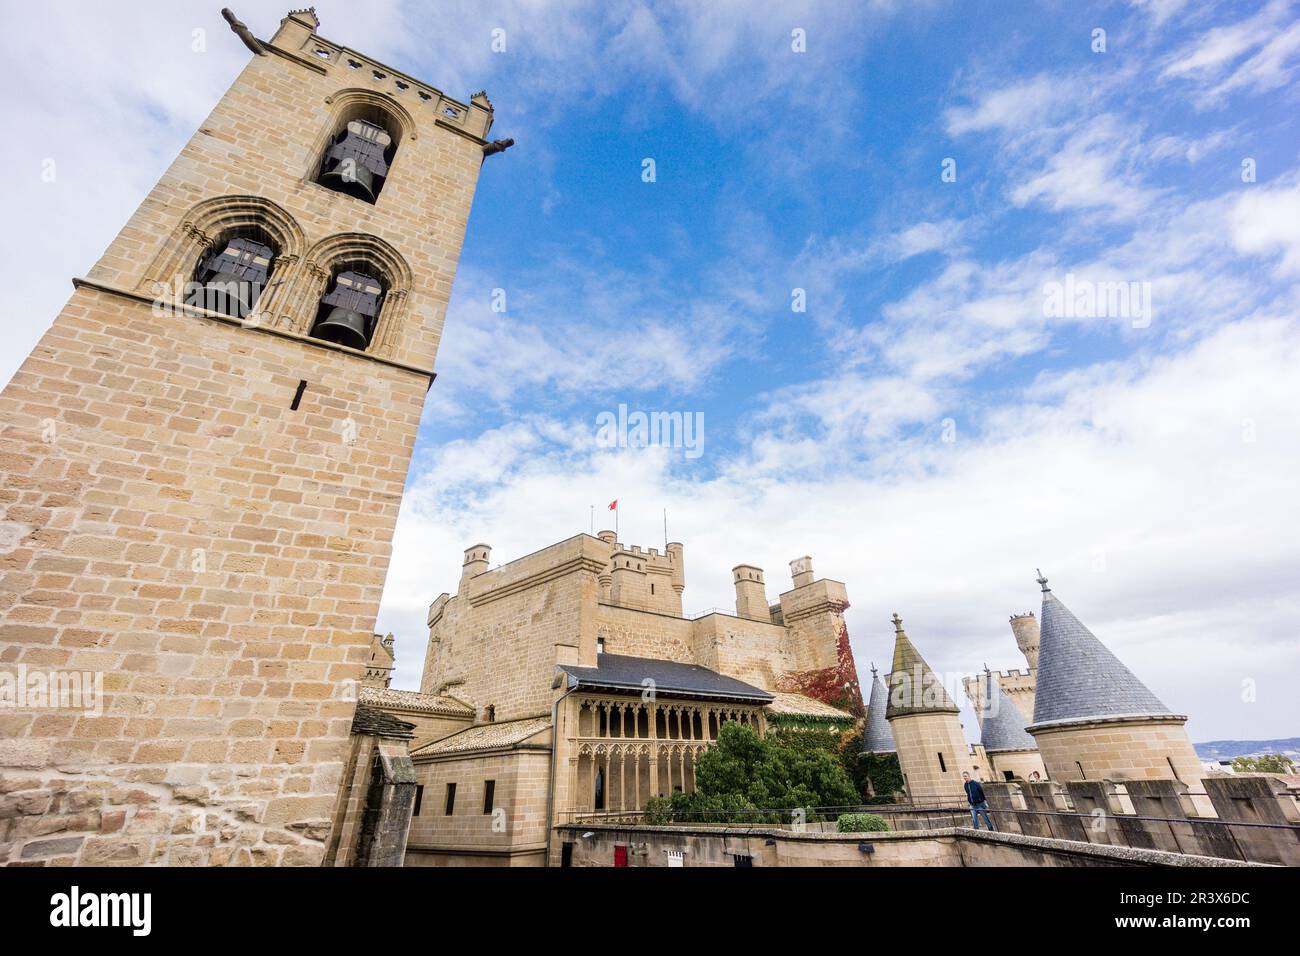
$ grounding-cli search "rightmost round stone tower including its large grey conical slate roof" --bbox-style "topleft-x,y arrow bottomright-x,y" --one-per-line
1027,574 -> 1201,786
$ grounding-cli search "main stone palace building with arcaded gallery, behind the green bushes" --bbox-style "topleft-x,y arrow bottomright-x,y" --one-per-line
379,531 -> 865,865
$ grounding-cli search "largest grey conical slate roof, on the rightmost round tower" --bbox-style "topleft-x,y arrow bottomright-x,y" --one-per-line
1031,574 -> 1171,728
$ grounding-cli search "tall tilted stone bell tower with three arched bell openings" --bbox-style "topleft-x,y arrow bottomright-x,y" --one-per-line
0,10 -> 508,865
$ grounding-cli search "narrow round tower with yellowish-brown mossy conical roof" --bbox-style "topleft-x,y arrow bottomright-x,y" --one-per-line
885,614 -> 969,804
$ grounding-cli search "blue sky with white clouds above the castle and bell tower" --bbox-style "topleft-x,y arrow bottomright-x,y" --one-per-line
0,0 -> 1300,740
